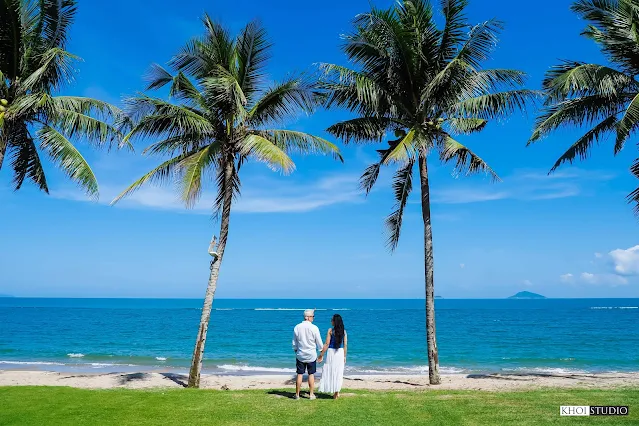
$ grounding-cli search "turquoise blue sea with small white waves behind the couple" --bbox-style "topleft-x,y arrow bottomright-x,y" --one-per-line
0,298 -> 639,374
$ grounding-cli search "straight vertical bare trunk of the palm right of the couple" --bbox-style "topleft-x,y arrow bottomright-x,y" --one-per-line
419,154 -> 441,385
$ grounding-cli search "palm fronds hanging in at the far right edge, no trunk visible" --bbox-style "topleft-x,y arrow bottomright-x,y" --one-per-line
528,0 -> 639,214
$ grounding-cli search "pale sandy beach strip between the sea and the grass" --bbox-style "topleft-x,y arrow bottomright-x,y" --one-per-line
0,370 -> 639,391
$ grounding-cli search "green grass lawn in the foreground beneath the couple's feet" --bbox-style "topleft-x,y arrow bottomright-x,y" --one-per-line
0,387 -> 639,426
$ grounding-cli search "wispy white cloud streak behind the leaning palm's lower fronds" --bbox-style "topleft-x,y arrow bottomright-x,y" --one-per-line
52,174 -> 363,214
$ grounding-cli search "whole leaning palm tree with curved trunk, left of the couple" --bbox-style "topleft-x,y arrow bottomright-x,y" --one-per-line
114,15 -> 341,387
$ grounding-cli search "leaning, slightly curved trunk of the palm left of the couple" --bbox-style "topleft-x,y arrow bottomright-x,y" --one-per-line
188,160 -> 234,388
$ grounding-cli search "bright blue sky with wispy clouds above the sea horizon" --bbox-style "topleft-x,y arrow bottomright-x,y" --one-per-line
0,0 -> 639,298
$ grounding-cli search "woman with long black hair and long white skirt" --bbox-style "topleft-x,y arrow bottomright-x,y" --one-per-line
318,314 -> 348,399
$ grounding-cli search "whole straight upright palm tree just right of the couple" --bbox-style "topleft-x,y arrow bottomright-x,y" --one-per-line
322,0 -> 532,384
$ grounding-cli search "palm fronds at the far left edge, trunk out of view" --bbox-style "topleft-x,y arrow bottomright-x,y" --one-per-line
0,0 -> 123,196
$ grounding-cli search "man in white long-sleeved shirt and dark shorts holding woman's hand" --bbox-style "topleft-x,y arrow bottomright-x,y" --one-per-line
293,309 -> 324,399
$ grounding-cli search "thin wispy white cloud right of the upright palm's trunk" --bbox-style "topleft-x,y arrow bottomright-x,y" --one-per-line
432,168 -> 614,204
